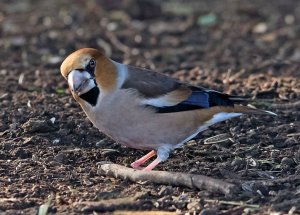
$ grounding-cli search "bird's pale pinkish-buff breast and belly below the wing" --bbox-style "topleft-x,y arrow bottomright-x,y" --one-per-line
79,90 -> 202,149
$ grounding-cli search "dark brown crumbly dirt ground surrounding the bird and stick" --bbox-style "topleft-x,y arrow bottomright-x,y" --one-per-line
0,0 -> 300,215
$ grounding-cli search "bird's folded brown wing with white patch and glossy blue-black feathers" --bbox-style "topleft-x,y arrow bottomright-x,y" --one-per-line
122,66 -> 245,113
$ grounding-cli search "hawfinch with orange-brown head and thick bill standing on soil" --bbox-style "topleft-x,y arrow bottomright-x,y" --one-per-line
60,48 -> 276,171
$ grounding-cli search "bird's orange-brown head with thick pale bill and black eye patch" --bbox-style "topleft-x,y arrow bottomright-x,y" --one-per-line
60,48 -> 117,103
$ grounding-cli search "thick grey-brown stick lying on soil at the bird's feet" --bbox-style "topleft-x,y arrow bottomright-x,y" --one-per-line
101,164 -> 239,195
